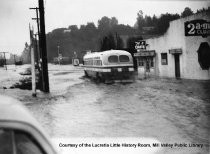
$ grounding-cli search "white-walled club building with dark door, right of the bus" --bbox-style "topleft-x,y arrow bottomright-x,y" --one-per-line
135,12 -> 210,80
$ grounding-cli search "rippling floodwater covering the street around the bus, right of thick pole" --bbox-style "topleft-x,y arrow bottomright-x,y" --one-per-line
0,65 -> 210,154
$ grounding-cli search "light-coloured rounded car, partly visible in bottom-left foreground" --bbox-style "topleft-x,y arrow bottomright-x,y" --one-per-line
0,95 -> 57,154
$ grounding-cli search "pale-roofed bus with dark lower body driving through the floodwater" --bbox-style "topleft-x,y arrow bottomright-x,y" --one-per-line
83,50 -> 134,82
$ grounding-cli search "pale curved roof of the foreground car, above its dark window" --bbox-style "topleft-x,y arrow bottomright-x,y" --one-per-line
0,95 -> 56,153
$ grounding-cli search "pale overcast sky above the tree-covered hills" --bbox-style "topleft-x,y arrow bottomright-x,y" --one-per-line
0,0 -> 210,53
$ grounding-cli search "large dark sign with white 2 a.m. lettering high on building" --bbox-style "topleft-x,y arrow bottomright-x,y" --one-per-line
184,19 -> 210,37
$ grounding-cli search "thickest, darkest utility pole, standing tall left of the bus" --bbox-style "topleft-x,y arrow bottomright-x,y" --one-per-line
38,0 -> 50,92
